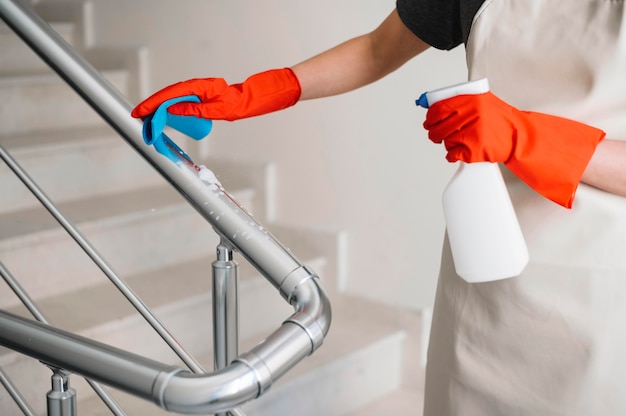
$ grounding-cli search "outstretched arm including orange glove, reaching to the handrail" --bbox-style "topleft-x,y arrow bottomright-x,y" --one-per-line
131,10 -> 428,121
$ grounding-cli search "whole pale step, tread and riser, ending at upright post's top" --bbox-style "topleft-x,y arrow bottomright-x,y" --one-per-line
0,186 -> 253,307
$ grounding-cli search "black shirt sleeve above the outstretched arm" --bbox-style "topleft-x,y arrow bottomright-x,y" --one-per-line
396,0 -> 485,50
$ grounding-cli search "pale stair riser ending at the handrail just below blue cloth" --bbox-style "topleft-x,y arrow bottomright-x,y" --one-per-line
0,136 -> 163,214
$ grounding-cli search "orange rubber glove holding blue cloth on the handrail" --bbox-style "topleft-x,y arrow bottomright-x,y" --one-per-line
131,68 -> 301,121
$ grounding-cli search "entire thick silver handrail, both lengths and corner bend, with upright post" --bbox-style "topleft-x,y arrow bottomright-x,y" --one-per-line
0,0 -> 331,415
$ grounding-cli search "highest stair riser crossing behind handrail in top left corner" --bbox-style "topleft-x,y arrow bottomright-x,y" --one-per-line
0,22 -> 75,76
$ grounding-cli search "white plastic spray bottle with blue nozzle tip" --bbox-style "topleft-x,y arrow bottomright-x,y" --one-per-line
418,78 -> 528,282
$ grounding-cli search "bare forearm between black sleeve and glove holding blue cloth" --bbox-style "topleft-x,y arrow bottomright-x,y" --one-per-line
292,10 -> 428,100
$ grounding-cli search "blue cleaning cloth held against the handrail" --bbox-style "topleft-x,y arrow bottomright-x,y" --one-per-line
142,95 -> 213,163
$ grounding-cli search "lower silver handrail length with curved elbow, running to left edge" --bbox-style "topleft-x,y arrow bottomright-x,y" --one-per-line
0,270 -> 330,414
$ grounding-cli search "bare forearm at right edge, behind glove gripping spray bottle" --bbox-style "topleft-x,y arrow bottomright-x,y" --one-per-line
581,139 -> 626,196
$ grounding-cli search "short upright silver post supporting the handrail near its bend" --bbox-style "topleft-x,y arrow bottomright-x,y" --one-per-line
213,241 -> 239,416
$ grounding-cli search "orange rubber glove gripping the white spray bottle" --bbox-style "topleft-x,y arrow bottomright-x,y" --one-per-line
424,92 -> 605,208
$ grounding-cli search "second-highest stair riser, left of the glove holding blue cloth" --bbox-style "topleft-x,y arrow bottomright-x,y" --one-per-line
0,70 -> 128,136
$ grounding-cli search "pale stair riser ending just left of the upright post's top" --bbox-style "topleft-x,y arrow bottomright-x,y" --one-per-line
0,205 -> 229,307
